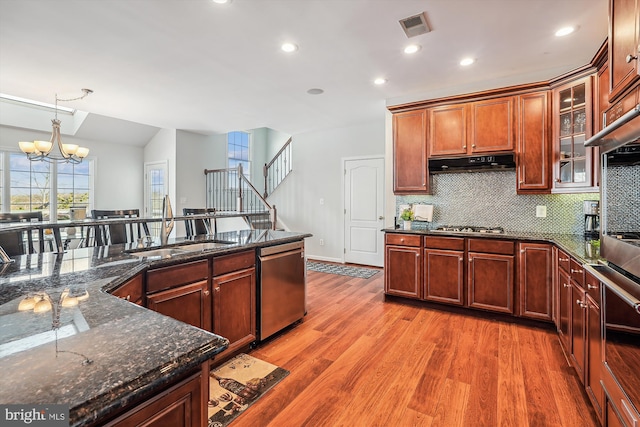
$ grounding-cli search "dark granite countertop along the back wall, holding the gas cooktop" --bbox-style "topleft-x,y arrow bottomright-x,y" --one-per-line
382,228 -> 604,265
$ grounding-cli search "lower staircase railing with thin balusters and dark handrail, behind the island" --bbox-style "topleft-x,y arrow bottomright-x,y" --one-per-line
204,164 -> 277,229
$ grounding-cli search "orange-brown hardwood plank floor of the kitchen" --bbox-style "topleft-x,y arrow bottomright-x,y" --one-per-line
232,271 -> 598,427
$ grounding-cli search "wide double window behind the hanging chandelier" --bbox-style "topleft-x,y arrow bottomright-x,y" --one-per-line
0,152 -> 93,221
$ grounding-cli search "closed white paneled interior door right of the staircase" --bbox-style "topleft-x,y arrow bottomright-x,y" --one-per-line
344,157 -> 384,267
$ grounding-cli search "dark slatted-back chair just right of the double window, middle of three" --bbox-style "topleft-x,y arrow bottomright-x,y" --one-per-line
91,209 -> 150,246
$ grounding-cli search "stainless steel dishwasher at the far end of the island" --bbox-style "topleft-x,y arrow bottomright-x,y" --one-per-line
258,241 -> 306,341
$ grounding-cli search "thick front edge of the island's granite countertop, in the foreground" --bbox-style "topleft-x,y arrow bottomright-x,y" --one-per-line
69,337 -> 229,427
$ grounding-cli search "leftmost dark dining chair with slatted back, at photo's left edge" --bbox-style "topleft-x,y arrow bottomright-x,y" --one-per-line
0,211 -> 44,256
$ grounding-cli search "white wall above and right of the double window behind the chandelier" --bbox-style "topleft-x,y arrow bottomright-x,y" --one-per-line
0,126 -> 144,210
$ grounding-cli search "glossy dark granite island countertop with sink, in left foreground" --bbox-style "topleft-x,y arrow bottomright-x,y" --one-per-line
0,230 -> 310,426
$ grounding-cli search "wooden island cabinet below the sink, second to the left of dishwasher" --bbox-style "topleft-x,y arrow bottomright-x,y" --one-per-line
146,260 -> 211,331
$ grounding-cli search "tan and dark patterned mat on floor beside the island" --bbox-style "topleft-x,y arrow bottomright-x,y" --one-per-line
208,353 -> 289,427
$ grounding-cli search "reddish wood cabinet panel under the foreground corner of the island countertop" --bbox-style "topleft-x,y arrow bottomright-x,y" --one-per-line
103,363 -> 209,427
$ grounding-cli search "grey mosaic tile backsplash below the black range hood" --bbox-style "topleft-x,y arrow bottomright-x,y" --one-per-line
396,171 -> 600,234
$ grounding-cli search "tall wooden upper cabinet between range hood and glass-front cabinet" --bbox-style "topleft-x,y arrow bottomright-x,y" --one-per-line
516,91 -> 551,194
